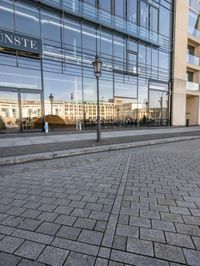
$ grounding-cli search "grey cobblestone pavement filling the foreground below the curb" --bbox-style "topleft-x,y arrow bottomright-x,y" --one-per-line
0,140 -> 200,266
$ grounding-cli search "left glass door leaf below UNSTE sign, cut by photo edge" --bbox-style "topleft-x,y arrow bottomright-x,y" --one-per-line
0,90 -> 20,133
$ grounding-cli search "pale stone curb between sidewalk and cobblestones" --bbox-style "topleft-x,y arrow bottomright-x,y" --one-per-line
0,136 -> 200,166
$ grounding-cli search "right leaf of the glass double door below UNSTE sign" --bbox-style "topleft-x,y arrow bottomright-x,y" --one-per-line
20,92 -> 42,132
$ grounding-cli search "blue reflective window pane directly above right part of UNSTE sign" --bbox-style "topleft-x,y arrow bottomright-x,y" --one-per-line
15,2 -> 40,37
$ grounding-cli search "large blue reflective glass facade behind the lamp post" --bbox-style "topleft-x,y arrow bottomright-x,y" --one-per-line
0,0 -> 173,131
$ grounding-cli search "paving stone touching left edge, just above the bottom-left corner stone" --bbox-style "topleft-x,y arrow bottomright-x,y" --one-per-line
0,236 -> 24,253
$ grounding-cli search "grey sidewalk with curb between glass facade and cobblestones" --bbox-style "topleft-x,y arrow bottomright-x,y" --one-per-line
0,127 -> 200,165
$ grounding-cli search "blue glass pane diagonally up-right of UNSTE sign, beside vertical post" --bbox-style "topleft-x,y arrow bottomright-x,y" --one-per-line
41,11 -> 62,45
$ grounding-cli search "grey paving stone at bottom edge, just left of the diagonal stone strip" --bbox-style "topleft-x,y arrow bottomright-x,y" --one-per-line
64,252 -> 95,266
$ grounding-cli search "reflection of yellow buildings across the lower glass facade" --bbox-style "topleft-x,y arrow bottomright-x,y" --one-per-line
0,98 -> 146,129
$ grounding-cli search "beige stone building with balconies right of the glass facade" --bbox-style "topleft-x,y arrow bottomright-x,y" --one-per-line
171,0 -> 200,126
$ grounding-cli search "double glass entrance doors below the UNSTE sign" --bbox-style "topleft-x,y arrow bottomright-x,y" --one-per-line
0,88 -> 42,133
